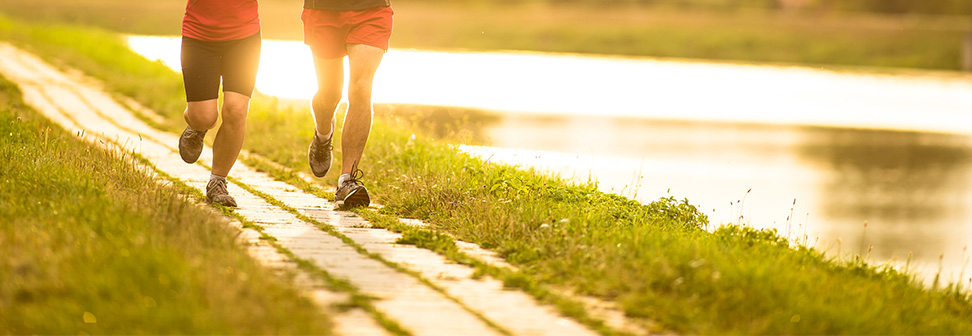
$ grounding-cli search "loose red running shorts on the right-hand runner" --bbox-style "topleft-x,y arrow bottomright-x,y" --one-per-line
300,6 -> 395,58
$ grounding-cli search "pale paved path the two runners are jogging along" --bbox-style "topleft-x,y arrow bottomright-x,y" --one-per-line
0,43 -> 636,335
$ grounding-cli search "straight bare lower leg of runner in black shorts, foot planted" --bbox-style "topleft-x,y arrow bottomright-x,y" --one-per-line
213,91 -> 250,176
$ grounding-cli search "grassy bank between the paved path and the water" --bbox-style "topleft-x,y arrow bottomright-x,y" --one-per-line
5,11 -> 972,334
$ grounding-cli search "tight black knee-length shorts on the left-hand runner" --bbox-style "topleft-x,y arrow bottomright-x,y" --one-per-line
182,32 -> 262,102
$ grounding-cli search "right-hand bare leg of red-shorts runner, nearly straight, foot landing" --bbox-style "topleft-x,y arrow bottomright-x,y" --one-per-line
341,44 -> 385,174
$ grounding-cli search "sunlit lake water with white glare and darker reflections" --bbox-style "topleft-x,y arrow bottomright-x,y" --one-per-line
129,36 -> 972,279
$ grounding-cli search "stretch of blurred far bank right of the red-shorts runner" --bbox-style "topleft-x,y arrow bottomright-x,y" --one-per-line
393,4 -> 972,70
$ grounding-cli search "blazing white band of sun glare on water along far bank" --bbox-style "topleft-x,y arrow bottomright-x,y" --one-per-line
129,36 -> 972,134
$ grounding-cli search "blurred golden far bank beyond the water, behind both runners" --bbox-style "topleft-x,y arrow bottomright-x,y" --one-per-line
0,0 -> 972,70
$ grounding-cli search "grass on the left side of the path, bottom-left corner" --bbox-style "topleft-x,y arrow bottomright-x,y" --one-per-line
0,69 -> 330,334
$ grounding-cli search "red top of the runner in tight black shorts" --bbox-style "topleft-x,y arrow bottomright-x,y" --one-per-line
182,0 -> 260,41
